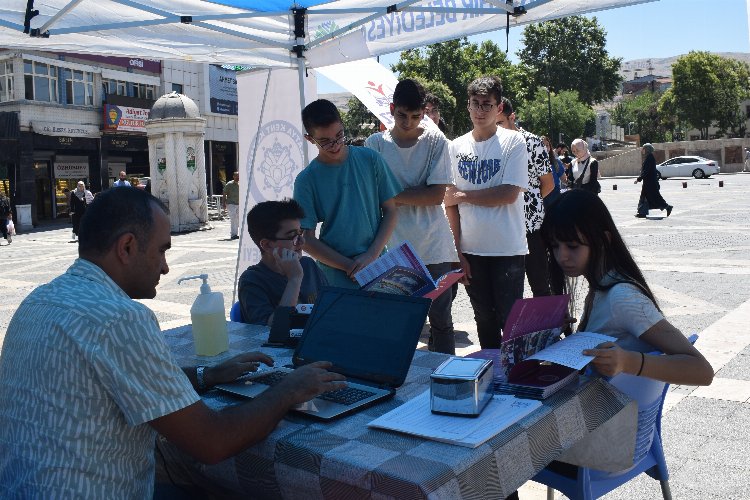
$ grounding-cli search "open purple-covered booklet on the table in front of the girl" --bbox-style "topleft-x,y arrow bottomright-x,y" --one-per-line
469,295 -> 615,399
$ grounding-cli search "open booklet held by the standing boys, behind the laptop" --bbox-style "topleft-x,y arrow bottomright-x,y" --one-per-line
354,241 -> 464,299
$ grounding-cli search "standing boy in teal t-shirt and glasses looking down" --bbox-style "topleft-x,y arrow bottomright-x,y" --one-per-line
294,99 -> 401,288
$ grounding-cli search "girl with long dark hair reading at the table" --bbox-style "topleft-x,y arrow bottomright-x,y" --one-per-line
541,189 -> 714,385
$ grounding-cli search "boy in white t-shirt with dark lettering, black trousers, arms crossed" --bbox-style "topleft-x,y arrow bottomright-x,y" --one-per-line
445,76 -> 529,349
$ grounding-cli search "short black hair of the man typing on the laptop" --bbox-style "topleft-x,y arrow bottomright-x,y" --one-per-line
78,184 -> 169,257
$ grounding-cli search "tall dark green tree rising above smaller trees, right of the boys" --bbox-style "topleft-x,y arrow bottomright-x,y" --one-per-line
517,16 -> 622,105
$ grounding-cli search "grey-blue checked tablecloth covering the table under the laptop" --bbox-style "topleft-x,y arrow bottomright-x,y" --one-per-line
157,322 -> 637,499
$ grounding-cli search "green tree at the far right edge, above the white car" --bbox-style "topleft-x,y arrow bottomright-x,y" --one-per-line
672,51 -> 750,139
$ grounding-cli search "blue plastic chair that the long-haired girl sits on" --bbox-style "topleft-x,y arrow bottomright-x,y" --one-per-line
532,334 -> 698,500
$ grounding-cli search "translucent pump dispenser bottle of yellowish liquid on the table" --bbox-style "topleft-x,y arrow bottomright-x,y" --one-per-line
177,274 -> 229,356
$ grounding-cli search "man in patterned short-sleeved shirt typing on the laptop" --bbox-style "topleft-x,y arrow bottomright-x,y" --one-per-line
0,189 -> 344,498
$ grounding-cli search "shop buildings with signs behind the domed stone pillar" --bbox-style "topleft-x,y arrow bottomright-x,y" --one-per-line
0,49 -> 238,225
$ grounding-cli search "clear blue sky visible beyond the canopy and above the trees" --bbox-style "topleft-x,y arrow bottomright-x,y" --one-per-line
318,0 -> 750,94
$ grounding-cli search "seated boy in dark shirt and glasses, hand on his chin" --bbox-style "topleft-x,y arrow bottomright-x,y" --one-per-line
239,199 -> 327,325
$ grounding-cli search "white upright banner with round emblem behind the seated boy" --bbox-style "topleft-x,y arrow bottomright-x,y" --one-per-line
234,69 -> 317,300
